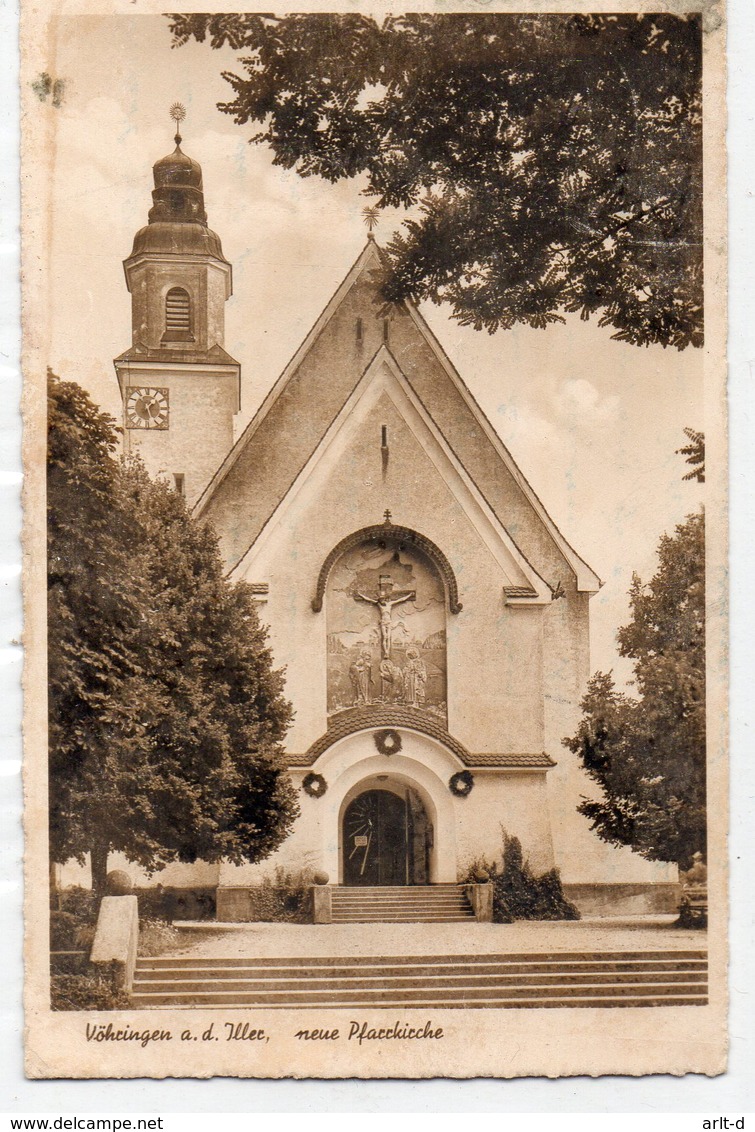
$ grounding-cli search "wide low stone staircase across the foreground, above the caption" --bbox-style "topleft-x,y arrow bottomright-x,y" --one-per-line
131,951 -> 707,1010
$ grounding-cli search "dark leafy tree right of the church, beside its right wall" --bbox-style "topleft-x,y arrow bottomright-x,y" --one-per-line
564,512 -> 705,868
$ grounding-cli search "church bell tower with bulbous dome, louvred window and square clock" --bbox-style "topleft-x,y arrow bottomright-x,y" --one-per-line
114,103 -> 241,506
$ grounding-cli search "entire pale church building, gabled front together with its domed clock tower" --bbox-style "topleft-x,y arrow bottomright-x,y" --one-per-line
101,128 -> 675,918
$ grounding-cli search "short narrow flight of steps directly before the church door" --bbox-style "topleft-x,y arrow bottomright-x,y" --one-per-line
332,884 -> 474,924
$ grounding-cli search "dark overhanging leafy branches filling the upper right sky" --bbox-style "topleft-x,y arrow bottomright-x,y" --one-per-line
170,14 -> 703,349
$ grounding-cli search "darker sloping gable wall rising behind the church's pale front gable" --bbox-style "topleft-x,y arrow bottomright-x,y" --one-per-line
195,237 -> 601,593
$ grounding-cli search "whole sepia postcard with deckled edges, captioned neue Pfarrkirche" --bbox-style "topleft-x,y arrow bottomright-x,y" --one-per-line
23,0 -> 728,1078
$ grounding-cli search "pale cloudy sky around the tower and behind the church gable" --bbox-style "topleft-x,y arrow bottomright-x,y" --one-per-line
48,15 -> 705,684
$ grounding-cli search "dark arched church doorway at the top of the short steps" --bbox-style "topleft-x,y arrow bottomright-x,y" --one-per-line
342,786 -> 432,885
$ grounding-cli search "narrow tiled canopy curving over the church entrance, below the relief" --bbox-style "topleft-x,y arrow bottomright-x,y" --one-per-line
286,704 -> 556,769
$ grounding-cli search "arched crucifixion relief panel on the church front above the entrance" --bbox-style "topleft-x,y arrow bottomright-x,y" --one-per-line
324,526 -> 447,726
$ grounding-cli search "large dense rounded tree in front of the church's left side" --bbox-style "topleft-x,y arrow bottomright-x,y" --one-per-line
48,377 -> 298,892
